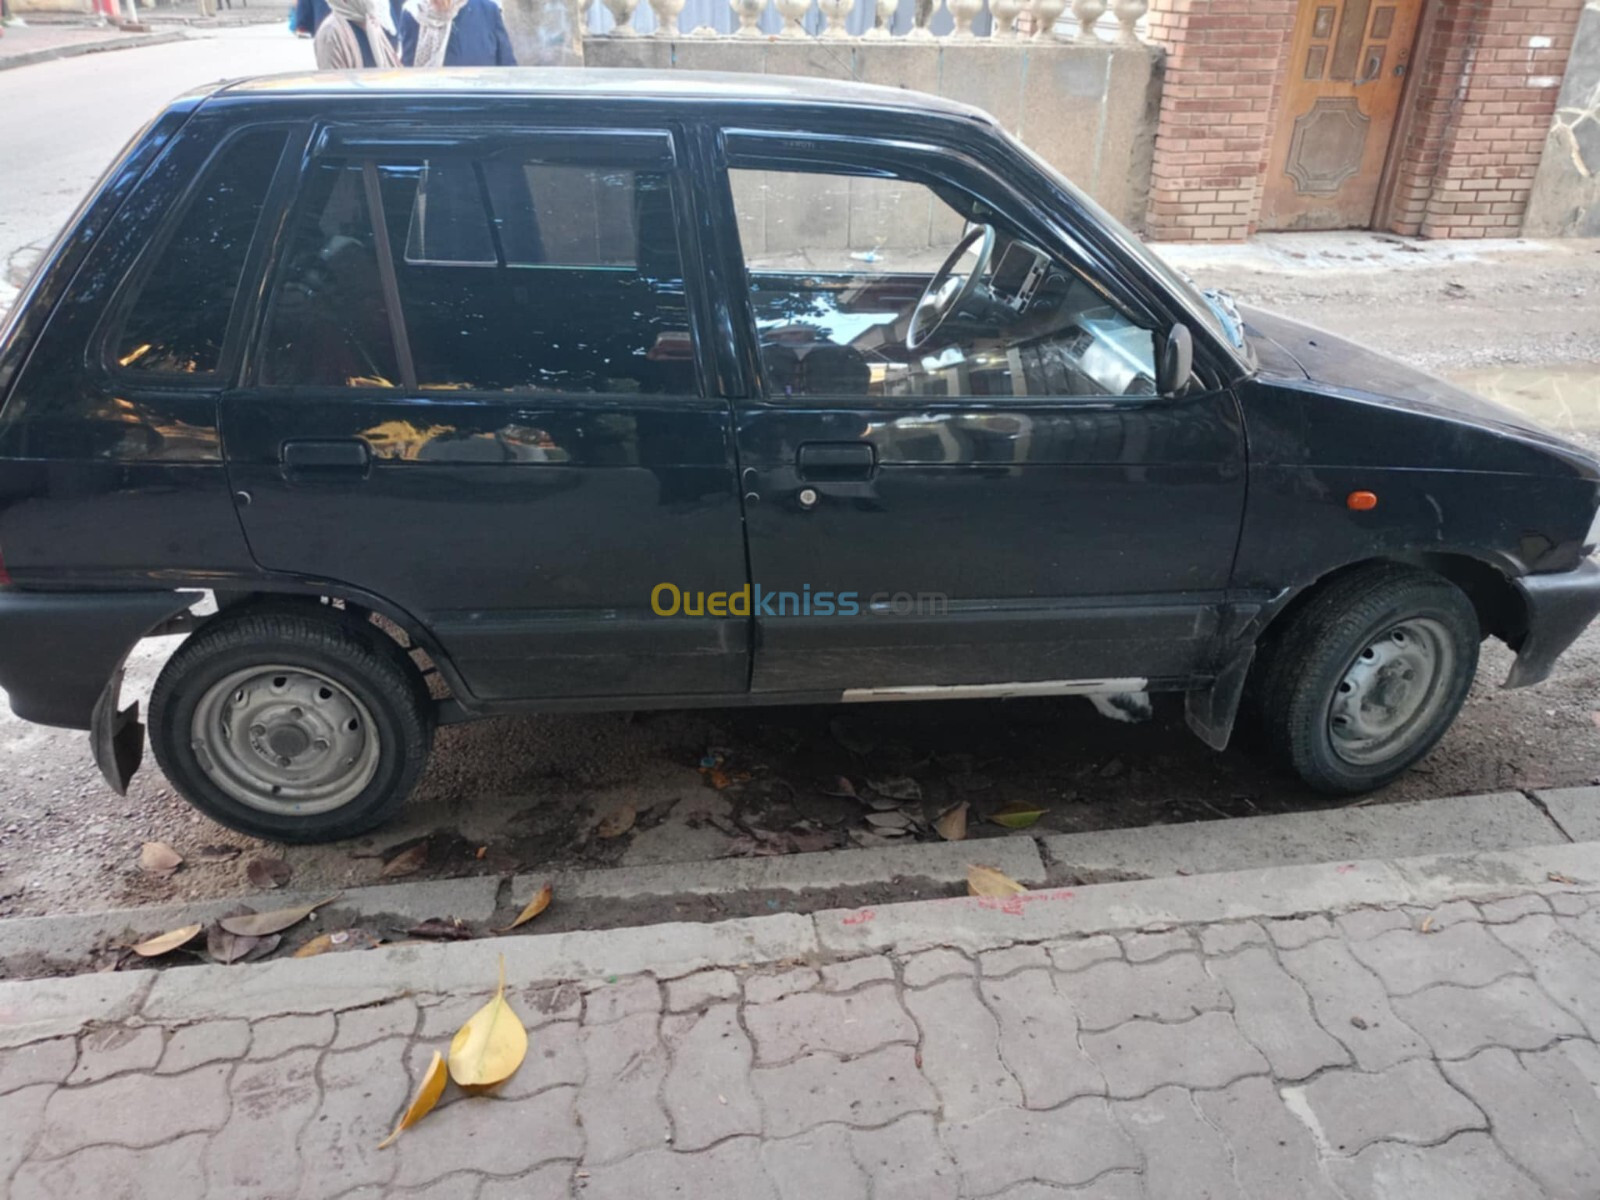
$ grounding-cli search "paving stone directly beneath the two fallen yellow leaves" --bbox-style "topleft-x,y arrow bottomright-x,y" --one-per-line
389,1088 -> 584,1187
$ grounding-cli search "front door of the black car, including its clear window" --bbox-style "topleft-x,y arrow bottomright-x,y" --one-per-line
709,130 -> 1245,699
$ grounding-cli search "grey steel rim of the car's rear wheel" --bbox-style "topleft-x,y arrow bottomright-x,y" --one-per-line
190,664 -> 381,816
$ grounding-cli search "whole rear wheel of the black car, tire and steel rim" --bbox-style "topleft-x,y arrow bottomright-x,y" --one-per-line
150,610 -> 432,842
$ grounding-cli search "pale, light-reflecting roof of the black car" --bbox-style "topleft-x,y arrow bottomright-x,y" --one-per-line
211,67 -> 994,123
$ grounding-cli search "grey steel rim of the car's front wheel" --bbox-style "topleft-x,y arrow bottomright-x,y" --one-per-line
1328,618 -> 1456,766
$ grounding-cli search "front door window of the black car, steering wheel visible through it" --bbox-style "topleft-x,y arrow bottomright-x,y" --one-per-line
730,170 -> 1155,397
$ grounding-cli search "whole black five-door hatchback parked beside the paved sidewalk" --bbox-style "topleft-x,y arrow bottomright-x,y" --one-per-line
0,70 -> 1600,842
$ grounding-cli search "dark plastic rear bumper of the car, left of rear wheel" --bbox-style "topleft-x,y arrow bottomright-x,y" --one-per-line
0,592 -> 200,730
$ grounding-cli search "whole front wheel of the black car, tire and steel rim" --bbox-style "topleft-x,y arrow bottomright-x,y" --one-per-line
1256,563 -> 1482,795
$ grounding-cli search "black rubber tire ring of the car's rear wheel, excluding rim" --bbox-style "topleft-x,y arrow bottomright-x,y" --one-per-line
150,608 -> 434,843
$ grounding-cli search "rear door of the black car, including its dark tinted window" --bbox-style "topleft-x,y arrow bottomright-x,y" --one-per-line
221,125 -> 749,702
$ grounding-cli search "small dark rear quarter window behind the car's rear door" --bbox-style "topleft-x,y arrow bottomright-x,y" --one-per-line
112,130 -> 288,376
